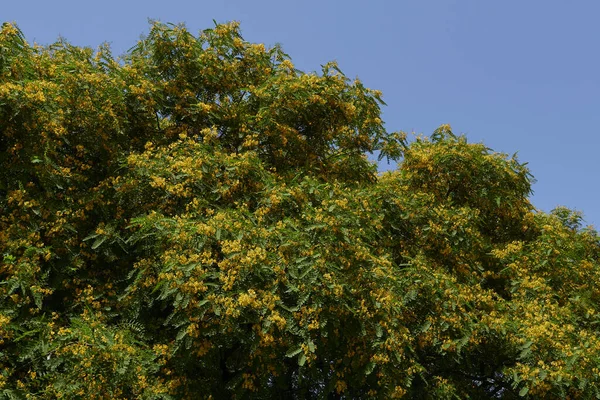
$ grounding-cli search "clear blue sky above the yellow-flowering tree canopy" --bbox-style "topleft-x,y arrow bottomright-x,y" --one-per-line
0,0 -> 600,226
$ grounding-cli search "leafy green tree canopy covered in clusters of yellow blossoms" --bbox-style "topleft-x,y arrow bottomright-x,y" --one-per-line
0,23 -> 600,399
